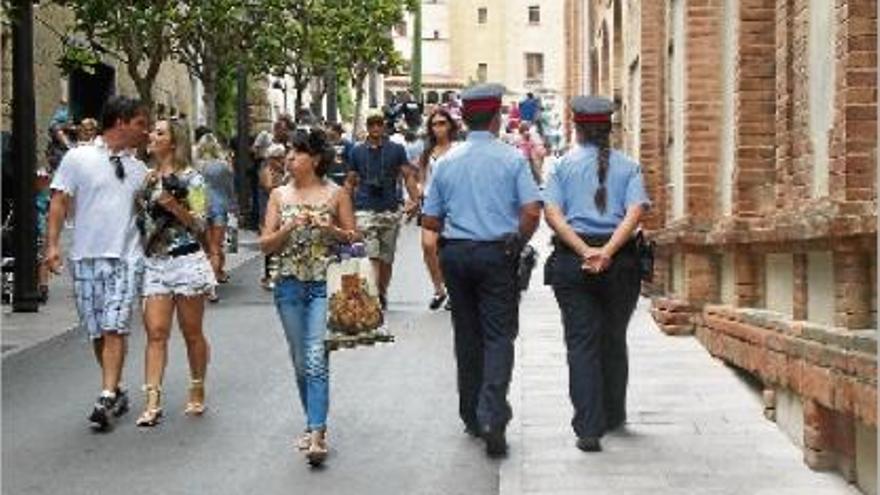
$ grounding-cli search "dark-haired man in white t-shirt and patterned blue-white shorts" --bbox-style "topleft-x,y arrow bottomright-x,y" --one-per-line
46,96 -> 149,430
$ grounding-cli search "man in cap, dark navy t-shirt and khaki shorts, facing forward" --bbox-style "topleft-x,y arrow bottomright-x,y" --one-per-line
346,114 -> 419,309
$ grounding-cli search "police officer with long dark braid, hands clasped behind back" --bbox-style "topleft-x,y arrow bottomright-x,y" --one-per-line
544,96 -> 650,452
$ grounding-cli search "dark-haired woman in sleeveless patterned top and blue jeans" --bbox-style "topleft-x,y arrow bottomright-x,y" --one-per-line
260,129 -> 358,465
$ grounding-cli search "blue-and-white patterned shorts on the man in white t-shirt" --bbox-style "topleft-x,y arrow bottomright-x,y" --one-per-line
70,258 -> 144,340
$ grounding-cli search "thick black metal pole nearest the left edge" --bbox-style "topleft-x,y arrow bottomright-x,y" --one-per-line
12,0 -> 39,313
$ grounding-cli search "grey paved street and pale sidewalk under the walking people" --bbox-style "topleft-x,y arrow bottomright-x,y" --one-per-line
2,227 -> 857,495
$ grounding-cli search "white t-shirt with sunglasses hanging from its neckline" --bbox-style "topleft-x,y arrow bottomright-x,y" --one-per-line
51,141 -> 147,261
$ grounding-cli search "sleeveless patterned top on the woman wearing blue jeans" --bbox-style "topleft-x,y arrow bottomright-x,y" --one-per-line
274,187 -> 337,282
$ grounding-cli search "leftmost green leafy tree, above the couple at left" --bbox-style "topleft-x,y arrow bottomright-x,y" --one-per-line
56,0 -> 178,106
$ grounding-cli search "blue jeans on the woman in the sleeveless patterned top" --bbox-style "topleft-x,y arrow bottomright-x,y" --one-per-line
275,277 -> 330,431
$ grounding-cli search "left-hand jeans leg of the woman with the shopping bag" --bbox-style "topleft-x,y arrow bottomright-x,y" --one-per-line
275,278 -> 308,413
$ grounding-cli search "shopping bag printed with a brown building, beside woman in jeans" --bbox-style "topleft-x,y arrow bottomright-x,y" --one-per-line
326,257 -> 394,351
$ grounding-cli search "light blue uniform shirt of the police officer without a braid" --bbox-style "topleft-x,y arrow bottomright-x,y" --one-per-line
422,131 -> 541,241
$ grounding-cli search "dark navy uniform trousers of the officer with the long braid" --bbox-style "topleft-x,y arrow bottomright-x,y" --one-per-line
548,237 -> 641,438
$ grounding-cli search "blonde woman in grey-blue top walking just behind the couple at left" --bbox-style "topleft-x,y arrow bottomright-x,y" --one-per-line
196,133 -> 237,294
